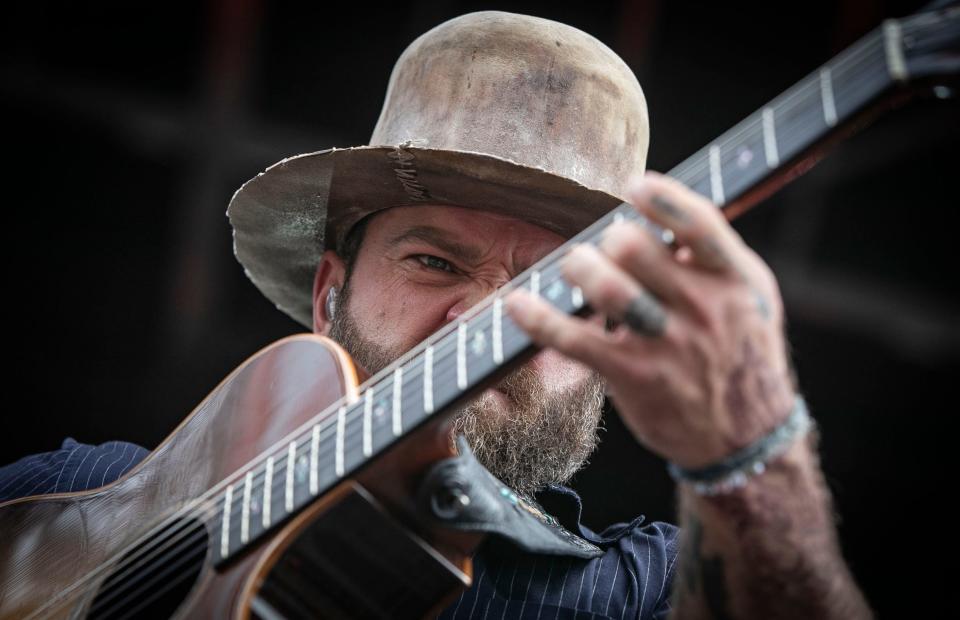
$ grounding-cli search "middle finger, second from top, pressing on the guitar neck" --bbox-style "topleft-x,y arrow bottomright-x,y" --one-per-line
599,221 -> 691,306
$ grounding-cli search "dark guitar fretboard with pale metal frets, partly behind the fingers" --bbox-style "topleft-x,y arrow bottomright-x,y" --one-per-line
207,15 -> 924,563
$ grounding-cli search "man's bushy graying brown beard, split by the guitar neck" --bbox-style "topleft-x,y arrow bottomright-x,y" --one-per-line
330,283 -> 604,496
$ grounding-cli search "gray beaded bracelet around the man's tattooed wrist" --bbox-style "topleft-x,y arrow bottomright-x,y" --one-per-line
667,395 -> 815,495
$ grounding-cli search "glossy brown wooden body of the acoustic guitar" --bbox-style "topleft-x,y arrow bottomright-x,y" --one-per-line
0,335 -> 477,619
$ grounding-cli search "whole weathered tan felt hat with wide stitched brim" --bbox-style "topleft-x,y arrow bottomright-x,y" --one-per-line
227,11 -> 649,327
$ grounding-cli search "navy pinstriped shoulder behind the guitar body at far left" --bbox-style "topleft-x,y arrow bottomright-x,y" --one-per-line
0,439 -> 149,502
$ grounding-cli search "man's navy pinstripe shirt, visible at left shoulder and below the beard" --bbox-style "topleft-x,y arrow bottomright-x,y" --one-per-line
0,439 -> 680,620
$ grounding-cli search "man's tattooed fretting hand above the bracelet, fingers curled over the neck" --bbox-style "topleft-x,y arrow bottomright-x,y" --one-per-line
507,173 -> 793,468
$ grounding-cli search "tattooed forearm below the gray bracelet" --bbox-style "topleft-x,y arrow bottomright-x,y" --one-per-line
671,432 -> 873,619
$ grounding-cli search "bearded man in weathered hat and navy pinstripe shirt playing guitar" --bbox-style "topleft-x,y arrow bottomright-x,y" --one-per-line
0,12 -> 870,618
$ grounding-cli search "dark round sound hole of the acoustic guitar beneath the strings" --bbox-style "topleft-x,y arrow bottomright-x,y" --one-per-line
88,519 -> 208,620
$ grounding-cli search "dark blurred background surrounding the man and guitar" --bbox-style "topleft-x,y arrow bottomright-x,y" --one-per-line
0,0 -> 960,616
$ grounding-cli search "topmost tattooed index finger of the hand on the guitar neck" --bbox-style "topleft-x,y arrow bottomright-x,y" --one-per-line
627,173 -> 743,273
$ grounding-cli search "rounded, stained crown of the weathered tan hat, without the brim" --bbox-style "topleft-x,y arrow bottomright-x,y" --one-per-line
370,11 -> 649,197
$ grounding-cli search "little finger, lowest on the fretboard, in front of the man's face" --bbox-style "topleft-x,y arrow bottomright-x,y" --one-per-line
504,290 -> 628,376
